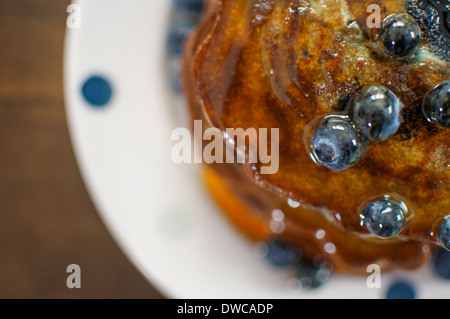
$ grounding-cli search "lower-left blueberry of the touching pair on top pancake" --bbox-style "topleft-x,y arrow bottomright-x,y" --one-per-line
311,115 -> 367,171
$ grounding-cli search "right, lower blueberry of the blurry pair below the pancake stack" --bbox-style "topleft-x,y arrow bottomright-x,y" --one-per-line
297,260 -> 331,289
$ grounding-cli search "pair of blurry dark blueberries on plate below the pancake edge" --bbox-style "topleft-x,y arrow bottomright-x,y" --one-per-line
266,238 -> 331,289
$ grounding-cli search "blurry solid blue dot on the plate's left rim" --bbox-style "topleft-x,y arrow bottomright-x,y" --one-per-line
81,75 -> 113,108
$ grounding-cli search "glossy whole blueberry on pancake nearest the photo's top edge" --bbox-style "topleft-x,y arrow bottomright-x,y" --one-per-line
378,13 -> 420,58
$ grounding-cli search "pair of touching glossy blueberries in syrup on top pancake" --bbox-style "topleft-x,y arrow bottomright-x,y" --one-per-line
310,85 -> 403,171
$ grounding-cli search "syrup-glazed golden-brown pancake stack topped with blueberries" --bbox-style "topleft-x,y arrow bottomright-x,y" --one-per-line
183,0 -> 450,273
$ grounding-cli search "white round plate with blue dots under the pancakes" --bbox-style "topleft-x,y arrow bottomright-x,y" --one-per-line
64,0 -> 450,298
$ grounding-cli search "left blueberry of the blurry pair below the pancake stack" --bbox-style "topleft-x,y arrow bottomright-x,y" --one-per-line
266,238 -> 301,268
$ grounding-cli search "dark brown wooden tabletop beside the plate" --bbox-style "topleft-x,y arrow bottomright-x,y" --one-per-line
0,0 -> 161,298
